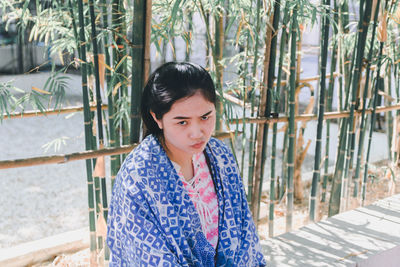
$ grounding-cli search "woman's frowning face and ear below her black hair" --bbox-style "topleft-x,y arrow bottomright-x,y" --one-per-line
151,91 -> 216,159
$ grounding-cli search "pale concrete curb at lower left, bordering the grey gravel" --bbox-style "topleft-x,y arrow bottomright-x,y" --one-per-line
0,228 -> 89,267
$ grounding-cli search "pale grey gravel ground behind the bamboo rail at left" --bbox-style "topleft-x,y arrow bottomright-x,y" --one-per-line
0,73 -> 88,248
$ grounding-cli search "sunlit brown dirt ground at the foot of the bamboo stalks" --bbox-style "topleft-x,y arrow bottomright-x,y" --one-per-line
32,162 -> 400,267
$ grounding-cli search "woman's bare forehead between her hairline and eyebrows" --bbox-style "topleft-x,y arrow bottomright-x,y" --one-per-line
165,91 -> 215,117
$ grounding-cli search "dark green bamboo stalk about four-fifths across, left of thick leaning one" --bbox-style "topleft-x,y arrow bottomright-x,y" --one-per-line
309,0 -> 330,222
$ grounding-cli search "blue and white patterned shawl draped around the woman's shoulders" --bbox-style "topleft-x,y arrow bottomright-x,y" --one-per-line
107,135 -> 266,266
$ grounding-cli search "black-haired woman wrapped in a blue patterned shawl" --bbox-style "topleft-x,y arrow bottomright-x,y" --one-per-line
107,62 -> 265,266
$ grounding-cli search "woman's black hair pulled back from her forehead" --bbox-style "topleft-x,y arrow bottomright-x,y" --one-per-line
140,62 -> 216,136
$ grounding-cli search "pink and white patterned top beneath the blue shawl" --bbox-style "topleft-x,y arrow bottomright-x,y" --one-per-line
173,153 -> 218,248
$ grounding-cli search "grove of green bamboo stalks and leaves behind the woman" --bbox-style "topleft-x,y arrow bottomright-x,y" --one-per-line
0,0 -> 400,265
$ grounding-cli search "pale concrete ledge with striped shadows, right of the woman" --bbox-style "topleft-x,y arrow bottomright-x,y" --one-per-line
261,195 -> 400,267
